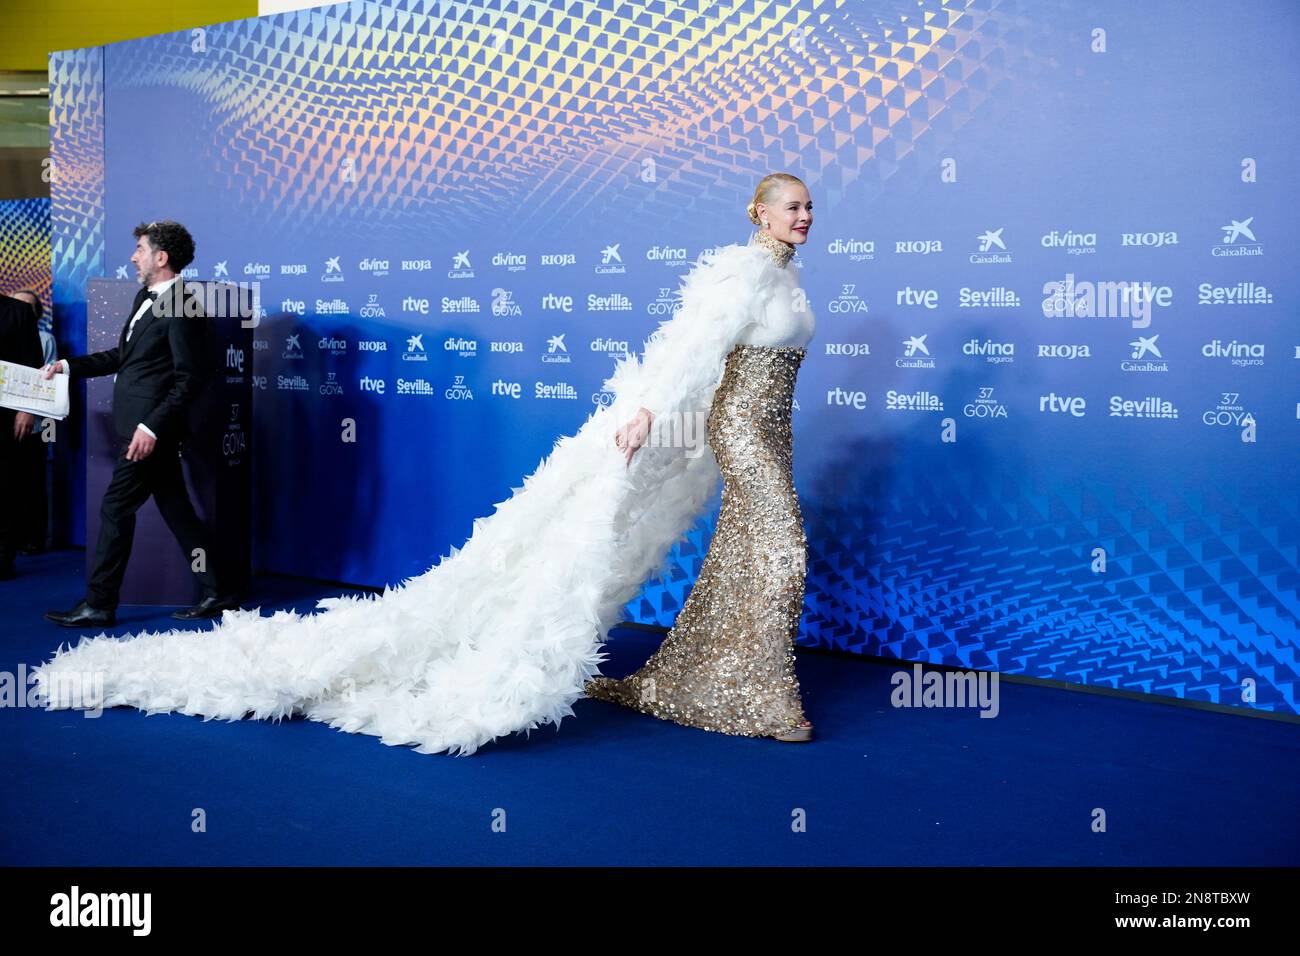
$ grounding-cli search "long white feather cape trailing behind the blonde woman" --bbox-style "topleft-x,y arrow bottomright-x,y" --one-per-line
35,243 -> 779,754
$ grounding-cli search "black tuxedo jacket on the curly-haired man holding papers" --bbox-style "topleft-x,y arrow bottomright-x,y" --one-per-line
68,278 -> 208,441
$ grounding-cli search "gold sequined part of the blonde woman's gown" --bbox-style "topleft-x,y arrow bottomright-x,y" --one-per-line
586,231 -> 807,736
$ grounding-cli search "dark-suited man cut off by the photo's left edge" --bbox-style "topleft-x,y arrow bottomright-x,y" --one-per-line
0,295 -> 44,581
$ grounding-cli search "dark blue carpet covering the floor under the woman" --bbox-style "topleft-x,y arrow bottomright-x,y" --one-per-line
0,551 -> 1300,866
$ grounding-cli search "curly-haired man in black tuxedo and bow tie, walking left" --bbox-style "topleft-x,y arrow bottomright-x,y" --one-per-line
46,220 -> 238,627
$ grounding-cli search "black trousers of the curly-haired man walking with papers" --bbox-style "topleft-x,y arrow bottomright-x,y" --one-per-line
86,441 -> 221,610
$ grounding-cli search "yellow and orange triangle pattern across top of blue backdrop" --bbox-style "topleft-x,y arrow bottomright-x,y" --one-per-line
78,0 -> 1002,243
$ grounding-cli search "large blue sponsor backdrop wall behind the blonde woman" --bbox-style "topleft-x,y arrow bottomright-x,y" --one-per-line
51,0 -> 1300,713
